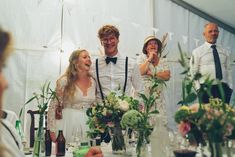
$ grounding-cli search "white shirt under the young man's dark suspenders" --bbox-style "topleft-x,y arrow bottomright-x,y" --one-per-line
91,53 -> 143,99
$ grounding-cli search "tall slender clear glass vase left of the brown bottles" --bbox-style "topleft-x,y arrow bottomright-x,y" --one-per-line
33,114 -> 45,157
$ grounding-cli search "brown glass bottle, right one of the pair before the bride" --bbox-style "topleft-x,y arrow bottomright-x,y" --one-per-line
56,130 -> 65,156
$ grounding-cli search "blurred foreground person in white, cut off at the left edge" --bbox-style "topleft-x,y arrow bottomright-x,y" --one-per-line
0,28 -> 24,157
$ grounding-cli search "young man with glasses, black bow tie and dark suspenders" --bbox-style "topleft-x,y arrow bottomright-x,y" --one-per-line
92,25 -> 143,100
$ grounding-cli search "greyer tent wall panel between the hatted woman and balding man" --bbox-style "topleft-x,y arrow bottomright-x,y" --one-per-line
154,0 -> 235,127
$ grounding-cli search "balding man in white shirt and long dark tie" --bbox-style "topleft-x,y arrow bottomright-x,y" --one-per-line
190,23 -> 233,103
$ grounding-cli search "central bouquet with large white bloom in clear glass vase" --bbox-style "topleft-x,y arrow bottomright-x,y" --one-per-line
87,92 -> 138,151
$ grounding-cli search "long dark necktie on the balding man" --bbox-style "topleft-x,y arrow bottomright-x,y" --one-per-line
211,45 -> 223,80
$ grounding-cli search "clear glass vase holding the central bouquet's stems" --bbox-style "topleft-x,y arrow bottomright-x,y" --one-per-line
112,122 -> 126,154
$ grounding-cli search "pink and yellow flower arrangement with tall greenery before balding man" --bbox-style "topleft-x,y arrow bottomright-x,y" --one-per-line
175,45 -> 235,157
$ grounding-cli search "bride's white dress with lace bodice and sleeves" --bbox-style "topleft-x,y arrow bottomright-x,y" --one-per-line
47,77 -> 96,142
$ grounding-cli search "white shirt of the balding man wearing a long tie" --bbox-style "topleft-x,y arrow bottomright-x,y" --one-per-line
190,42 -> 232,89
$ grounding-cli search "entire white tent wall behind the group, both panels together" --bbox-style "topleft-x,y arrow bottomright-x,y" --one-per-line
0,0 -> 235,145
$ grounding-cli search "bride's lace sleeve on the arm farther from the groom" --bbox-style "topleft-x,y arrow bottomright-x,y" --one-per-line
47,78 -> 66,132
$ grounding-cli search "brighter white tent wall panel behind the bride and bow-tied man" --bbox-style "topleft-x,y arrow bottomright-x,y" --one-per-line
0,0 -> 152,144
